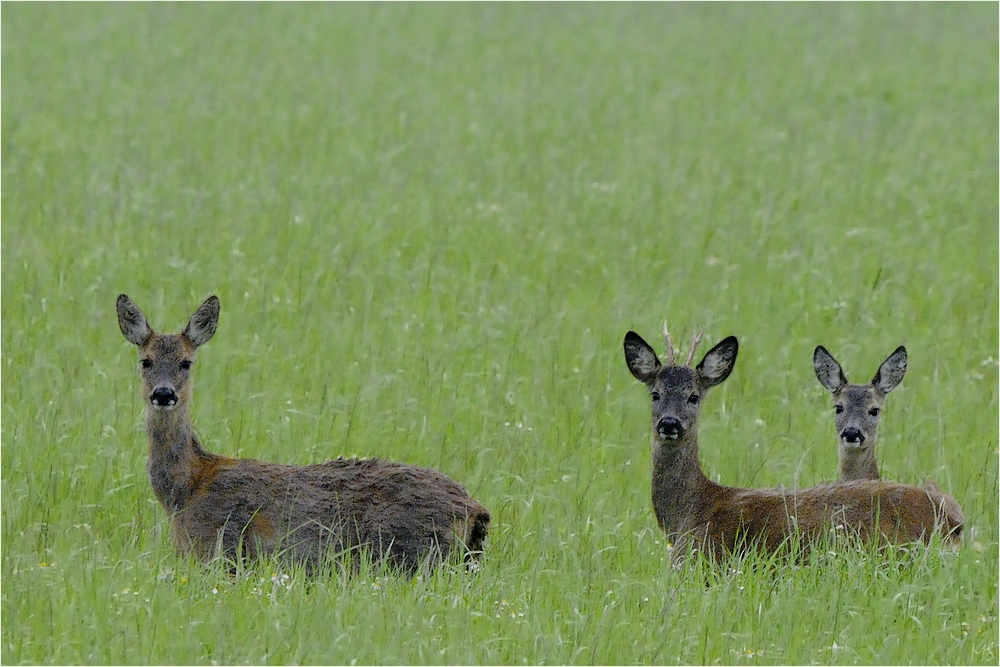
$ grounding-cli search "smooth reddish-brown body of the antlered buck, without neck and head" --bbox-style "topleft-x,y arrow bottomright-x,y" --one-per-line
675,480 -> 965,559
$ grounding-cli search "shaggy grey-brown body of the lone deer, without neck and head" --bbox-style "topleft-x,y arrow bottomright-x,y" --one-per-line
177,457 -> 489,572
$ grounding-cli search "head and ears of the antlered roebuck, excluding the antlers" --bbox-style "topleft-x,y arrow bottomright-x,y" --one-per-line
625,331 -> 739,444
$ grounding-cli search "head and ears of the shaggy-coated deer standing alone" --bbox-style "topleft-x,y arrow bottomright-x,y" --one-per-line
118,294 -> 219,410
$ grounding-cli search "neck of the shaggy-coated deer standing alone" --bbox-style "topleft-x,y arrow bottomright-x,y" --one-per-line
146,403 -> 210,513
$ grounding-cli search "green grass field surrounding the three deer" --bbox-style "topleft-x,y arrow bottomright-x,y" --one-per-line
0,3 -> 1000,664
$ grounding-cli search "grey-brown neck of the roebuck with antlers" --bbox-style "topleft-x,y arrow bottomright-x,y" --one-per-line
652,427 -> 713,541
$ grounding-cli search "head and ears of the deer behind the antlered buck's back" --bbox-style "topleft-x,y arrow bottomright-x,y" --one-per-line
813,345 -> 906,451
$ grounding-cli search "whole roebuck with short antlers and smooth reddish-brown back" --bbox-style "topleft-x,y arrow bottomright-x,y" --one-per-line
625,325 -> 964,560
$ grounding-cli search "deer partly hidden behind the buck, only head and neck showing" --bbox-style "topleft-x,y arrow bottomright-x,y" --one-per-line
813,345 -> 906,482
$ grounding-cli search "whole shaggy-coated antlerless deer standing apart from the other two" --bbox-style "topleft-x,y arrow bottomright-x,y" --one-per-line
118,294 -> 490,573
